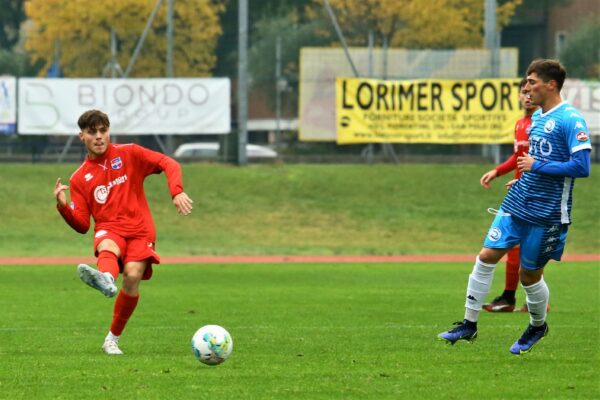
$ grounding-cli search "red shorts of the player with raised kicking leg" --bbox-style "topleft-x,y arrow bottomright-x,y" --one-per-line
94,230 -> 160,280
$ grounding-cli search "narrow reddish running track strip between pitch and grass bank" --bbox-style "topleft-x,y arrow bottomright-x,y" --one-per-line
0,254 -> 600,265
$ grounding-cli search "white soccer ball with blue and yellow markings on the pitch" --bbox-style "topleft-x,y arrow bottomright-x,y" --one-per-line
192,325 -> 233,365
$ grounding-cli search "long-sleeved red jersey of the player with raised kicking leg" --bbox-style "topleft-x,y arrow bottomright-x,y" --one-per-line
58,144 -> 183,242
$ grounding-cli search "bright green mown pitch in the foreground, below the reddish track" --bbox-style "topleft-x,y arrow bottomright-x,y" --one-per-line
0,263 -> 600,399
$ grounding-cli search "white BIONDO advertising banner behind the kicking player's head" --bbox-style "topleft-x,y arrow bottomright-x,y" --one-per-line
18,78 -> 231,135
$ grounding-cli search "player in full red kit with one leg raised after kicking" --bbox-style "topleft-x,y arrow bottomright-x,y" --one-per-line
54,110 -> 193,355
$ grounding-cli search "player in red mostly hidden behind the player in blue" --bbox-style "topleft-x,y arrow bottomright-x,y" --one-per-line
479,78 -> 537,312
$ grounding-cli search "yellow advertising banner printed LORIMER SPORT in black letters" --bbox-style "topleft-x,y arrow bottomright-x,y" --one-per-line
336,78 -> 523,144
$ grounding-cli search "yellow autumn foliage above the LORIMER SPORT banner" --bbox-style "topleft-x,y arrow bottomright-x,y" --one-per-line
311,0 -> 522,49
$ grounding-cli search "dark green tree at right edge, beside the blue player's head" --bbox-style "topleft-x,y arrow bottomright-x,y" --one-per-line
560,17 -> 600,79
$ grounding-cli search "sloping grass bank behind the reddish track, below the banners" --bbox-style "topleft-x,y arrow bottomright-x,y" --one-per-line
0,164 -> 600,257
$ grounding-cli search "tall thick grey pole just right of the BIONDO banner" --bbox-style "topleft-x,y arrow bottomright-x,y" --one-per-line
237,0 -> 248,165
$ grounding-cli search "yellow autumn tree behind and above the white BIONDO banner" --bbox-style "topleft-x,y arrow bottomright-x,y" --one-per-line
25,0 -> 224,77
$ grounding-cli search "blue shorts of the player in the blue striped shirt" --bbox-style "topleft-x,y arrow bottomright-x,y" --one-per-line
483,209 -> 569,270
